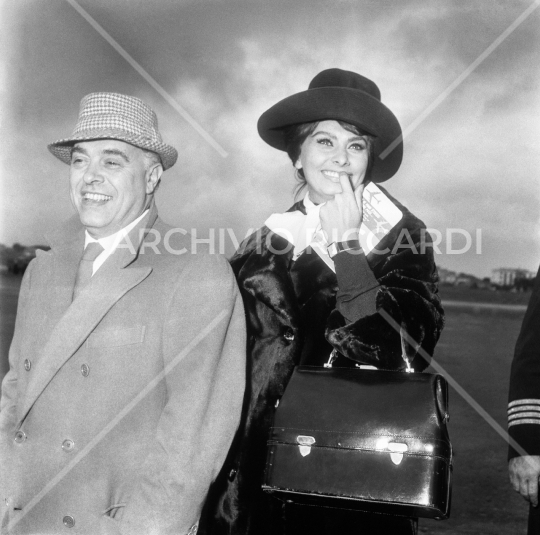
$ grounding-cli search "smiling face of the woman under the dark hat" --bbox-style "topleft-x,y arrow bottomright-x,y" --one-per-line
295,121 -> 369,204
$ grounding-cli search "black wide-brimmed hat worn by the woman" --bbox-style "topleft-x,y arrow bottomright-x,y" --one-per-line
257,69 -> 403,182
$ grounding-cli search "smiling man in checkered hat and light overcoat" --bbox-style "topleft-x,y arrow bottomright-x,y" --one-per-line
0,93 -> 245,535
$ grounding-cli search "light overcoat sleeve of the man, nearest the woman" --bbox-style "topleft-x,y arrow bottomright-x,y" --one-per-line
120,255 -> 246,535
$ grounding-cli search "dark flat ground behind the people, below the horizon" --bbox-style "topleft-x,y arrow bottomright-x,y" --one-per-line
0,276 -> 527,535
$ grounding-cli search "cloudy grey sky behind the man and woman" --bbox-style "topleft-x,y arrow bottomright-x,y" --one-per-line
0,0 -> 540,276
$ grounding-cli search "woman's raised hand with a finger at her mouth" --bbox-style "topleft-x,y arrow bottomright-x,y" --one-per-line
320,173 -> 365,244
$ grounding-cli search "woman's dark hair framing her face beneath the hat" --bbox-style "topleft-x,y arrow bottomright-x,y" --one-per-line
283,121 -> 375,199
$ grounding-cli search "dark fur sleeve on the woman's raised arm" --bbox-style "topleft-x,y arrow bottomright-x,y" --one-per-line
326,210 -> 444,371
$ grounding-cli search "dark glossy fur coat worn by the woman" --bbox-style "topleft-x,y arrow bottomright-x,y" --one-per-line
199,186 -> 443,535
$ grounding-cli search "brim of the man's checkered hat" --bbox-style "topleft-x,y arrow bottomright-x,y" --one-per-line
47,129 -> 178,169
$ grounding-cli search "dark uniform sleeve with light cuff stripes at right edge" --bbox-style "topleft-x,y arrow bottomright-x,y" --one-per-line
508,271 -> 540,459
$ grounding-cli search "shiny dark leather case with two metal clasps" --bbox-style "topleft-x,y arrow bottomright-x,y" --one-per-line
263,366 -> 452,519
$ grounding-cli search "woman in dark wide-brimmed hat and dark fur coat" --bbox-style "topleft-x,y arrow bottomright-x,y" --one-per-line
201,69 -> 443,535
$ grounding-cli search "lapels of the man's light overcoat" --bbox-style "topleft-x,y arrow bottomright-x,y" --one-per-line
19,207 -> 157,425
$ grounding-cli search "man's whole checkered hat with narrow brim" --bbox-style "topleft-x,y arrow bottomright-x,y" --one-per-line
48,93 -> 178,169
